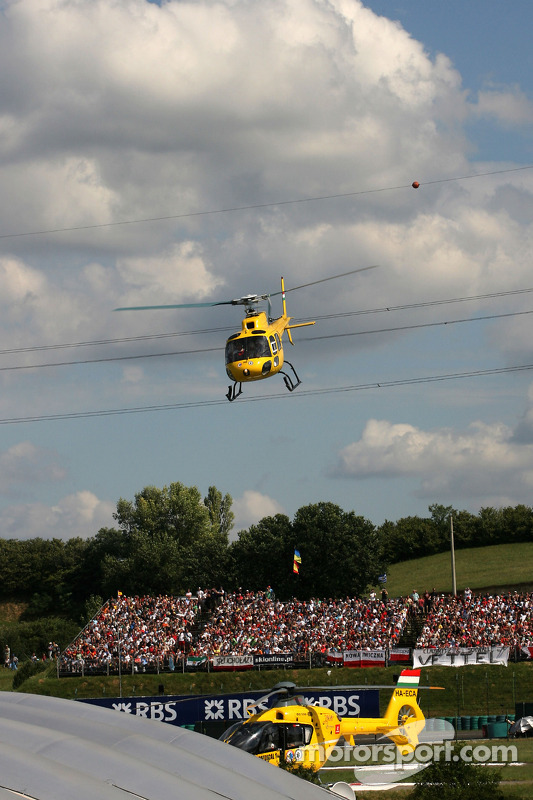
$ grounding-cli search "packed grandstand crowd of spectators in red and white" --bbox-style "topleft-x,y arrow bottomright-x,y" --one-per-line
60,587 -> 533,673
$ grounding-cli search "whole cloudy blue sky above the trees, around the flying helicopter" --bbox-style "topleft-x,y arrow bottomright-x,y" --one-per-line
0,0 -> 533,538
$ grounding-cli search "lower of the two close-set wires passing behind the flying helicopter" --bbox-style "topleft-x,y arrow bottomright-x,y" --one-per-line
0,310 -> 533,372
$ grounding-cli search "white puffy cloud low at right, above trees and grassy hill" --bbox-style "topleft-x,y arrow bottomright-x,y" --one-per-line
332,419 -> 533,502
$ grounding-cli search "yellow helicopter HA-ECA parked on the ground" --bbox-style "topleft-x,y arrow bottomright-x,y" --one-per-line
220,670 -> 432,771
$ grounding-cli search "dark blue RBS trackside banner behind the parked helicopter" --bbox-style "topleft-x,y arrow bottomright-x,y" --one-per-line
78,689 -> 379,725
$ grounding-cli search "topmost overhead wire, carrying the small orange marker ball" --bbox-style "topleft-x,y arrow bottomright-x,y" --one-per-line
0,164 -> 533,239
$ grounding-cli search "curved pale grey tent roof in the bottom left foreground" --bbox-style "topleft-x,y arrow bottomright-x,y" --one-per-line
0,692 -> 331,800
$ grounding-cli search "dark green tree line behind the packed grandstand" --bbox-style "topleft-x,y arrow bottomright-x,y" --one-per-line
0,483 -> 533,621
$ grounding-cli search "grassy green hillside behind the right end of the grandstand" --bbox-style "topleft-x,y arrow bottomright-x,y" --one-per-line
372,542 -> 533,597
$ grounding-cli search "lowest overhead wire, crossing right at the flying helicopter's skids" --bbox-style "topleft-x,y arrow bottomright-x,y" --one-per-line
0,364 -> 533,425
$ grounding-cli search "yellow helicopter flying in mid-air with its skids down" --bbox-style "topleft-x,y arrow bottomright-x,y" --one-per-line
115,265 -> 377,402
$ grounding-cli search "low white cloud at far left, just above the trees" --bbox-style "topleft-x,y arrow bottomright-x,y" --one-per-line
0,491 -> 116,539
